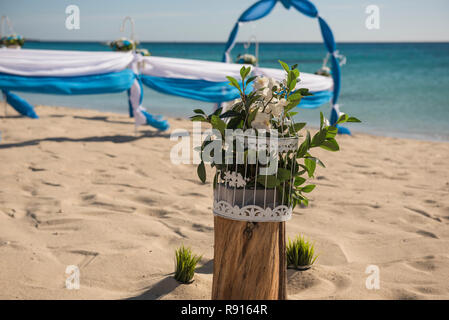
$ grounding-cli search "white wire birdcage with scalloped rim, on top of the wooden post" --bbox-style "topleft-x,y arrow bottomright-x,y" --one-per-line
213,135 -> 299,222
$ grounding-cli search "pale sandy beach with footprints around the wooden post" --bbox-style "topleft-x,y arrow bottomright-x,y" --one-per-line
0,106 -> 449,299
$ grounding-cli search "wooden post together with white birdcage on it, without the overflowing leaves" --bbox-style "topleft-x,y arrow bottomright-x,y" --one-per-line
212,132 -> 299,299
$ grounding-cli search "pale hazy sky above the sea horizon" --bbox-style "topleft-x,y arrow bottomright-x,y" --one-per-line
0,0 -> 449,42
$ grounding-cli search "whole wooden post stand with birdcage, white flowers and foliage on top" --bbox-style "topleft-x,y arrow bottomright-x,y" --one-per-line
191,61 -> 359,300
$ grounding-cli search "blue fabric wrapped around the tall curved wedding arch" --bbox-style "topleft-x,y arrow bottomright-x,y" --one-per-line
223,0 -> 349,133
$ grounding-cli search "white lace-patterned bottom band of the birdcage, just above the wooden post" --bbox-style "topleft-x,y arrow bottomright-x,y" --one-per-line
213,200 -> 292,222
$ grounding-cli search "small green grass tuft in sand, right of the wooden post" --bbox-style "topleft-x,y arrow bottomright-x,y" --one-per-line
286,235 -> 317,269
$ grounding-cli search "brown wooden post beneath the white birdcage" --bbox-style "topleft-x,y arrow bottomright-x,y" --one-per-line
212,216 -> 287,300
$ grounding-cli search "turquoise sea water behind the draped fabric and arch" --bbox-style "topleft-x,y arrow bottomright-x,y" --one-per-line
21,42 -> 449,141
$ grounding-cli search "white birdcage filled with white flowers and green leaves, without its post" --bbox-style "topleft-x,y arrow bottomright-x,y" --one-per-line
191,61 -> 360,221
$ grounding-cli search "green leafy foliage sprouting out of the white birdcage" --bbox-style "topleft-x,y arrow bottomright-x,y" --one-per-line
190,61 -> 360,208
